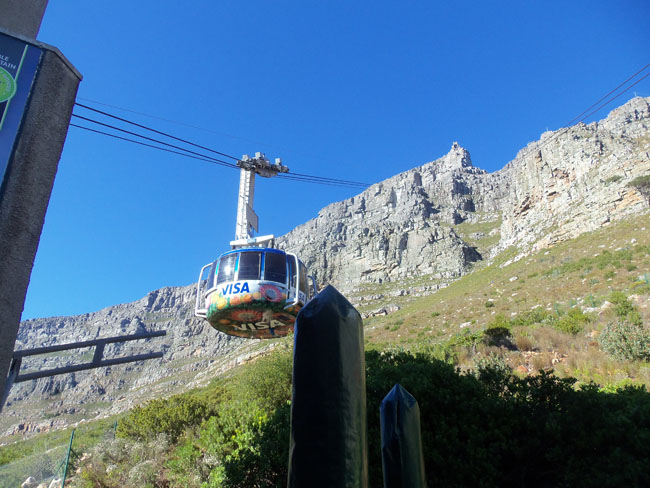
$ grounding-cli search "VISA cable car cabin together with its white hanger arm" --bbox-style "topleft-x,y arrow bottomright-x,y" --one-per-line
194,153 -> 317,339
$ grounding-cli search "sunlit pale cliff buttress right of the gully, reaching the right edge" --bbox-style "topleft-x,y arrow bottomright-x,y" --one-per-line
497,98 -> 650,252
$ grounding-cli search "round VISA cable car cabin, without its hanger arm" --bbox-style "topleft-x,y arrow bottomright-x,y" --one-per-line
195,247 -> 316,339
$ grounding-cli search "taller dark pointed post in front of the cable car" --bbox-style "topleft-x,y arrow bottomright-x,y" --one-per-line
288,286 -> 368,488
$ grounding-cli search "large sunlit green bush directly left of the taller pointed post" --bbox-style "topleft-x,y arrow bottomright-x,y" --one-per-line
166,350 -> 293,488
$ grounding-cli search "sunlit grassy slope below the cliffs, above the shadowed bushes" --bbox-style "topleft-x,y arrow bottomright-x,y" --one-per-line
365,215 -> 650,386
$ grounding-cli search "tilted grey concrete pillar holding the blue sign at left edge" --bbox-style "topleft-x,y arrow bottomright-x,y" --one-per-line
0,23 -> 81,404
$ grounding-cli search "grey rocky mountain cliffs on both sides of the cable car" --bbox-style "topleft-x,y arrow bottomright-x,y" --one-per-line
0,98 -> 650,434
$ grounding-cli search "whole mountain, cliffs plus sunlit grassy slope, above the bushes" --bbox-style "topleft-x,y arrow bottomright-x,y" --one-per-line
0,98 -> 650,436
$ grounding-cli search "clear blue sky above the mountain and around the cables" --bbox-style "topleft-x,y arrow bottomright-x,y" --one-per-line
23,0 -> 650,319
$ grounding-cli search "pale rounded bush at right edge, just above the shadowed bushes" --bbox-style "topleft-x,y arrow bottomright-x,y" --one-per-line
598,320 -> 650,361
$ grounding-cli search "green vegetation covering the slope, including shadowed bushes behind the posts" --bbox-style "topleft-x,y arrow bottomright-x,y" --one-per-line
5,216 -> 650,488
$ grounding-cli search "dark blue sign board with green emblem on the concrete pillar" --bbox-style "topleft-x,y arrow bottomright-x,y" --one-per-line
0,32 -> 43,196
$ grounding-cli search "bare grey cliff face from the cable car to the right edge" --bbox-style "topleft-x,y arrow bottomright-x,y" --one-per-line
278,98 -> 650,290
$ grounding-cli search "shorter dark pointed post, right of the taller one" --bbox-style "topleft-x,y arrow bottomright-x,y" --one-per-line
379,384 -> 427,488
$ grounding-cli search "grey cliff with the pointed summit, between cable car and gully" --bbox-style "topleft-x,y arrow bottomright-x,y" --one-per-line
277,143 -> 508,289
